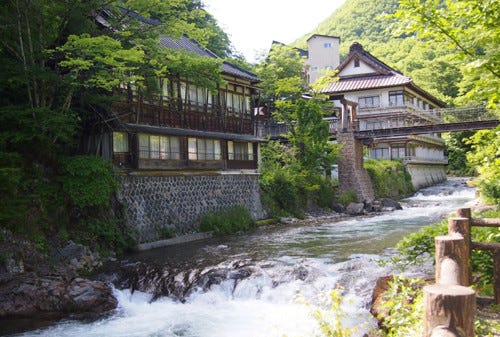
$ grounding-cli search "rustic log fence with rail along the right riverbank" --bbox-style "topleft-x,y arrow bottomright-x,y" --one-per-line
424,208 -> 500,337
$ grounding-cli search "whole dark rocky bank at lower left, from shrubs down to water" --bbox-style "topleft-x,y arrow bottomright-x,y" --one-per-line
0,229 -> 118,319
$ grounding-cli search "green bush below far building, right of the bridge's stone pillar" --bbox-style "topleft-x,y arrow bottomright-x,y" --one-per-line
364,159 -> 415,199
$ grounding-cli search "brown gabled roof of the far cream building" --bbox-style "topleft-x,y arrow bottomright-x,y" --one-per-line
321,42 -> 446,107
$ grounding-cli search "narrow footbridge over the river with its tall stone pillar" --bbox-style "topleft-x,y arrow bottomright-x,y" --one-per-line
261,105 -> 499,201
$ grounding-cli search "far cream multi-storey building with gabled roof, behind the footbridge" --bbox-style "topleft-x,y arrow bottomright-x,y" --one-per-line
314,39 -> 448,189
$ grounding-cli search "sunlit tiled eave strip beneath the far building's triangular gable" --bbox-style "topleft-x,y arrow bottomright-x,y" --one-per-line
321,74 -> 412,94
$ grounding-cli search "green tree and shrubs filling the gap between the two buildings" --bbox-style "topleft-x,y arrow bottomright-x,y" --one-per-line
257,44 -> 338,214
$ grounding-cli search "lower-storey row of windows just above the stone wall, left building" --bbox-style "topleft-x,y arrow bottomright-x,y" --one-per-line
113,132 -> 255,160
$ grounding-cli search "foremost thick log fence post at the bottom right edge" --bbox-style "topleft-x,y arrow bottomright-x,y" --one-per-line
424,284 -> 476,337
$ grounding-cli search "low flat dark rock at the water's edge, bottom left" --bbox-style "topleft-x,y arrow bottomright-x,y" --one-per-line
0,273 -> 118,318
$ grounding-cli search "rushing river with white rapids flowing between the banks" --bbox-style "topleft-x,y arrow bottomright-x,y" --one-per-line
8,179 -> 475,337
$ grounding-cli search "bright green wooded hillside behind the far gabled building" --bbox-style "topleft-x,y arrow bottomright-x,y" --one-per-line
293,0 -> 500,203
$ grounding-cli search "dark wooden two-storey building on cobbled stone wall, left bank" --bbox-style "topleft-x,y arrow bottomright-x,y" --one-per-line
88,36 -> 265,242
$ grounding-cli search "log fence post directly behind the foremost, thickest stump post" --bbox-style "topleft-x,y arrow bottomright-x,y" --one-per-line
434,234 -> 469,286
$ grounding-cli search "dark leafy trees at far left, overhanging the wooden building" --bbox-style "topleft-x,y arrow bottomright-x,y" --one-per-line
0,0 -> 231,249
